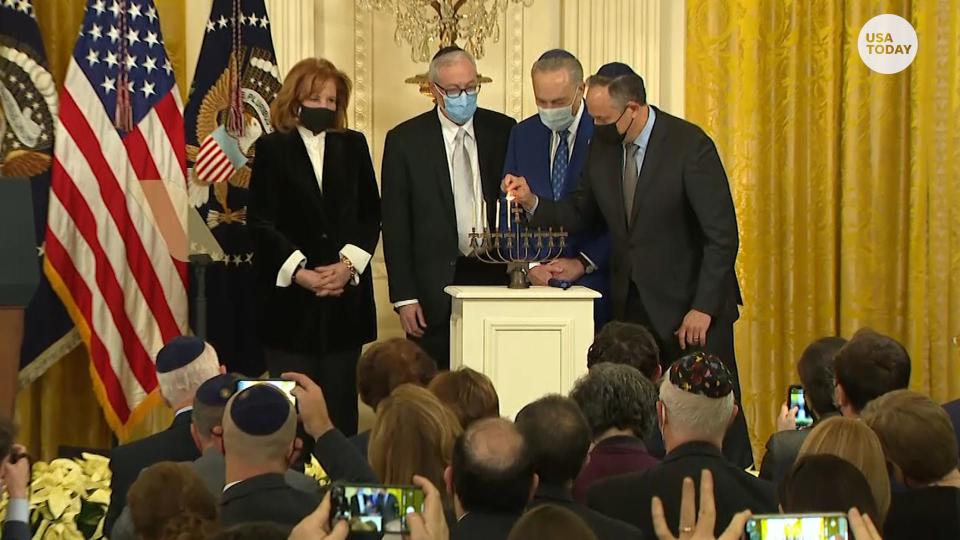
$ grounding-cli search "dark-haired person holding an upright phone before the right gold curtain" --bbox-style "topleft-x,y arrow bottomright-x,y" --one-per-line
760,337 -> 847,484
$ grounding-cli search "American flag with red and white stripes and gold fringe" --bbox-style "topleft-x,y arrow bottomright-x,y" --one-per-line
44,0 -> 188,439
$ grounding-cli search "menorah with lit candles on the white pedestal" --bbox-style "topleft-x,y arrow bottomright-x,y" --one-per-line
470,202 -> 567,289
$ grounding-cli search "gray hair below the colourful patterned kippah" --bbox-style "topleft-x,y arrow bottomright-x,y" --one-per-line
660,366 -> 734,441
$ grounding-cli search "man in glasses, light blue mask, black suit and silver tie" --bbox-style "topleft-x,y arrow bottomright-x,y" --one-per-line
381,46 -> 516,369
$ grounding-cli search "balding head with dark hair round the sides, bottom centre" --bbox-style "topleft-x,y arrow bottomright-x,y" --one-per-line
453,418 -> 535,512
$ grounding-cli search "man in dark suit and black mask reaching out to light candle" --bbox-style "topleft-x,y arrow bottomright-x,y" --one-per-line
504,63 -> 753,467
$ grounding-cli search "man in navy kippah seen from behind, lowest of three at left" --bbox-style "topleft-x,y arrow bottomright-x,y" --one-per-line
220,384 -> 320,531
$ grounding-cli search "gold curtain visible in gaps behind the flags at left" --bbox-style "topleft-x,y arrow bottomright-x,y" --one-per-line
16,0 -> 189,459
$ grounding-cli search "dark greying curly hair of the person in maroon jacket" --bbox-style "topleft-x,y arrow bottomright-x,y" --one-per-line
570,363 -> 657,439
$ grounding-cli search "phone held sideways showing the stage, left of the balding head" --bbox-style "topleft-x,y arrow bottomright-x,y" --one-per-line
330,484 -> 423,533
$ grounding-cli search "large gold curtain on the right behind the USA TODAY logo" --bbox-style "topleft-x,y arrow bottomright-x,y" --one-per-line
685,0 -> 960,458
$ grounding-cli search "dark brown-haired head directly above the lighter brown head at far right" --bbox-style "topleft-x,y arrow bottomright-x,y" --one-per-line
834,328 -> 910,418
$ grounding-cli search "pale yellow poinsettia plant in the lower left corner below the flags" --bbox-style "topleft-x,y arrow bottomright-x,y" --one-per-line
0,453 -> 110,540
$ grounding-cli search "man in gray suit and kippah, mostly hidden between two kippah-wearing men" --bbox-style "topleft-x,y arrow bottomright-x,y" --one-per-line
111,374 -> 321,540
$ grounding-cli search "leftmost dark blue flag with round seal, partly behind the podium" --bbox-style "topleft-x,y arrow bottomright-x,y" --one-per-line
0,0 -> 80,385
